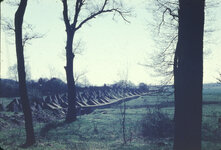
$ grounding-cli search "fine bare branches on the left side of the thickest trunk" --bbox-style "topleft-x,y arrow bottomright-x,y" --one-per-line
141,0 -> 179,83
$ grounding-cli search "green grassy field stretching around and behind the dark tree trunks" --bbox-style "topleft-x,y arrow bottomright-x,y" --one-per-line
0,87 -> 221,150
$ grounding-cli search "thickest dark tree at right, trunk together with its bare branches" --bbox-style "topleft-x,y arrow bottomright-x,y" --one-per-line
145,0 -> 212,150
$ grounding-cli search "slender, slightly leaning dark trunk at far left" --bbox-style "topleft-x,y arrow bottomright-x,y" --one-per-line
15,0 -> 35,146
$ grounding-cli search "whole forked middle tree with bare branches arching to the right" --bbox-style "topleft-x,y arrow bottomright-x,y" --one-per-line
62,0 -> 129,122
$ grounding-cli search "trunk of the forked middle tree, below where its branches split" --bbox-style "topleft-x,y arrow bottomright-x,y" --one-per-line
65,30 -> 77,123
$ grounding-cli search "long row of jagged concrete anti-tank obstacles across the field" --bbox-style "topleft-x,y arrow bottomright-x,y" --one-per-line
6,87 -> 150,113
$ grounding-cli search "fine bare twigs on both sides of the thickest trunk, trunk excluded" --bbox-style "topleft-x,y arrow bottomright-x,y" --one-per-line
142,0 -> 220,84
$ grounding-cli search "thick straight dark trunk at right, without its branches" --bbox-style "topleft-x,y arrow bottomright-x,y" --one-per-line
174,0 -> 205,150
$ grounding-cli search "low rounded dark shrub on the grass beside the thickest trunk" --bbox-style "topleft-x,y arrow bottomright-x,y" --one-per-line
141,111 -> 174,138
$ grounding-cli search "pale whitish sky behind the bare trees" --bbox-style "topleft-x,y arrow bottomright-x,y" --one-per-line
0,0 -> 221,85
